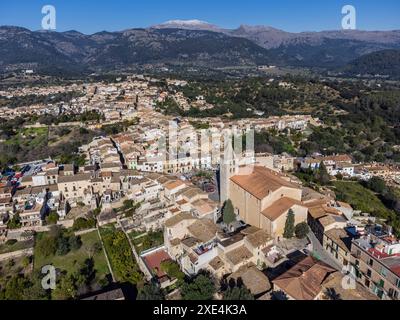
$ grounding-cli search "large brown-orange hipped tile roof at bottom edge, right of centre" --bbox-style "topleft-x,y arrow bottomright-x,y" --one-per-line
272,257 -> 336,300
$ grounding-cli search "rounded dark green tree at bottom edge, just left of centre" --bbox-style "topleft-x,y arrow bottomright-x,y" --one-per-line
181,274 -> 216,300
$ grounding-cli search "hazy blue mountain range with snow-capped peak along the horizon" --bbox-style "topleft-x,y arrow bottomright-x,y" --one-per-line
0,20 -> 400,72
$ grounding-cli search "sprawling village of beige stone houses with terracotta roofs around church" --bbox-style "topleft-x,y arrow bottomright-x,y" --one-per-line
0,76 -> 400,300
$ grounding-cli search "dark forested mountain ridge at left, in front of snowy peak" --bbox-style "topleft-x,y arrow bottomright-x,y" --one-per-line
0,27 -> 270,72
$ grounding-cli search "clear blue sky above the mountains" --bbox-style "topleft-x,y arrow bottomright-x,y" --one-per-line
0,0 -> 400,33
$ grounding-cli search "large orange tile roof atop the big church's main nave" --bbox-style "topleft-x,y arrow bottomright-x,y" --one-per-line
231,166 -> 298,200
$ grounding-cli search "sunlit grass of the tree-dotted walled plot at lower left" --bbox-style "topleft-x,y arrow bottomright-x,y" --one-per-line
34,231 -> 110,280
